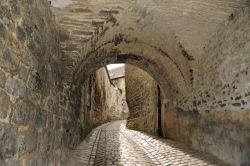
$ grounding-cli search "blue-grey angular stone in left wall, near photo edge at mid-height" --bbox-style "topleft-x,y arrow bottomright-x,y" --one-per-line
5,77 -> 27,97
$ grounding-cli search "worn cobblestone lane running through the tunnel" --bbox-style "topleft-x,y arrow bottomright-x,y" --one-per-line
65,121 -> 228,166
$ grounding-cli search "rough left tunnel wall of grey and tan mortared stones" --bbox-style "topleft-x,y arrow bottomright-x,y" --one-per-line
0,0 -> 78,165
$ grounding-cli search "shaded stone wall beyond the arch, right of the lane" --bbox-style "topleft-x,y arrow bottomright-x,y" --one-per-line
125,65 -> 158,134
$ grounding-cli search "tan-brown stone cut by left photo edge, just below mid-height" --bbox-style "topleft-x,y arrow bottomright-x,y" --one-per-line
0,89 -> 10,119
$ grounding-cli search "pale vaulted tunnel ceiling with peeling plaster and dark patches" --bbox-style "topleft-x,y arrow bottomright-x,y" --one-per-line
49,0 -> 250,93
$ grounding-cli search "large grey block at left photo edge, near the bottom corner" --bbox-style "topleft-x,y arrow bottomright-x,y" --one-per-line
0,124 -> 18,160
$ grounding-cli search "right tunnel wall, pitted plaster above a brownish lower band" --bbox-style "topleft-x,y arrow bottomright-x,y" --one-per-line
164,8 -> 250,166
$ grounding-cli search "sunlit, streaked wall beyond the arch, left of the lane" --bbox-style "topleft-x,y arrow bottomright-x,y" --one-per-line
80,68 -> 120,135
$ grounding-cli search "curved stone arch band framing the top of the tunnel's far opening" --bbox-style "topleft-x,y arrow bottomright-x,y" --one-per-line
73,41 -> 192,98
